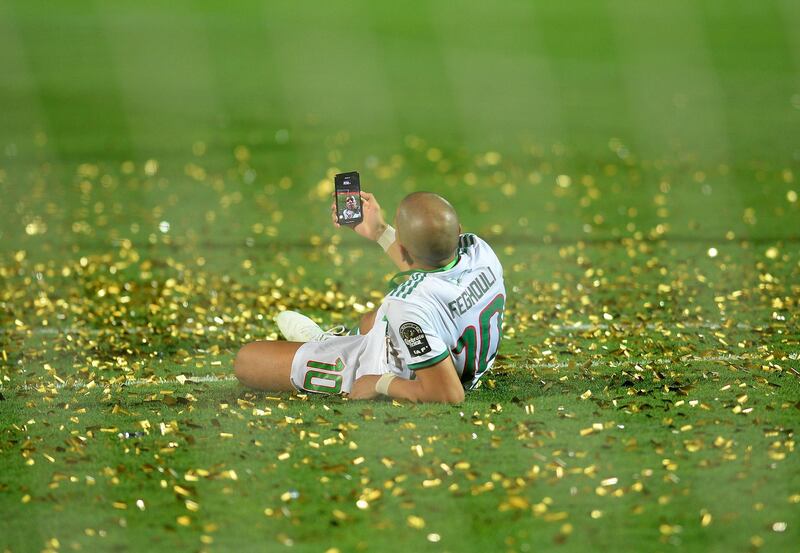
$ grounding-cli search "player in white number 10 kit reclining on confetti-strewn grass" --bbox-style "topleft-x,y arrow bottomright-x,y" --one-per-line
234,192 -> 505,403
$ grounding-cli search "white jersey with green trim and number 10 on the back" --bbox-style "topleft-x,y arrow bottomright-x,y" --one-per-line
377,234 -> 506,389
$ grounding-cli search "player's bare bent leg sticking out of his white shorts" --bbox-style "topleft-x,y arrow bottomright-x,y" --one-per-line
233,342 -> 303,392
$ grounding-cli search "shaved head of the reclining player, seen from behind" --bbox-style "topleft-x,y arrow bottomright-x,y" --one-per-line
395,192 -> 461,267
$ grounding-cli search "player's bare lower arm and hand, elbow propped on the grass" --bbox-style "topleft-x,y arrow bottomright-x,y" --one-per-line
349,356 -> 464,403
